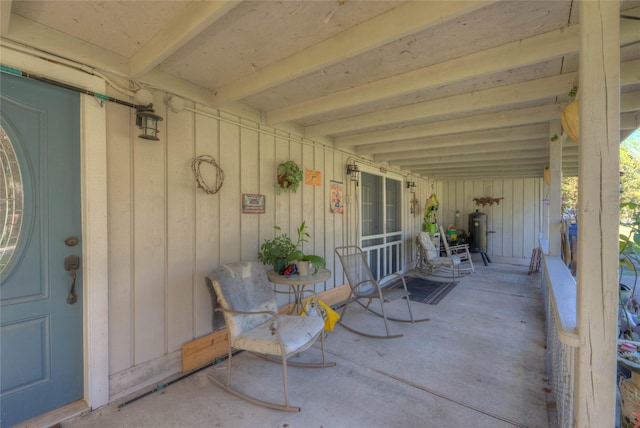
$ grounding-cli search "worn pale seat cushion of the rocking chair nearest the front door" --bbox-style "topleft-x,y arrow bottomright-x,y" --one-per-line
231,315 -> 324,355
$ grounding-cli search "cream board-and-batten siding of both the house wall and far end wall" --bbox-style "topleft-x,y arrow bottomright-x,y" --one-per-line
105,88 -> 542,400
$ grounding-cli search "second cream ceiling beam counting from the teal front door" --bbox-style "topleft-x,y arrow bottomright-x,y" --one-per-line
212,1 -> 495,106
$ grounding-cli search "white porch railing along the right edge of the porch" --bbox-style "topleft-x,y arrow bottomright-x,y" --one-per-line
541,252 -> 580,428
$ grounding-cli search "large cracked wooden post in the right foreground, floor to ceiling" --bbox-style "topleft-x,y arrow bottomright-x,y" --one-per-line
574,0 -> 620,428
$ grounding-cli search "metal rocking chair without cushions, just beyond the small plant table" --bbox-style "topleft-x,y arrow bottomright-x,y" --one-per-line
335,245 -> 429,339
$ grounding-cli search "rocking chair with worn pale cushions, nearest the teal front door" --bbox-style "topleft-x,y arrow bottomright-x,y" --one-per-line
207,262 -> 335,412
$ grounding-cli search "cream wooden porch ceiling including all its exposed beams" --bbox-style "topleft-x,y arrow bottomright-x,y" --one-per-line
0,0 -> 640,179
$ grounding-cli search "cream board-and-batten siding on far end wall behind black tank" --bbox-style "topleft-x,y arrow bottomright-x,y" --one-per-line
436,178 -> 548,264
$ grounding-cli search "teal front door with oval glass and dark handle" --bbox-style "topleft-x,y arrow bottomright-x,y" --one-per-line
0,73 -> 84,427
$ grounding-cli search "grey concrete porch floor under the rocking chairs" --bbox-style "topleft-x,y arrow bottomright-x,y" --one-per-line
62,255 -> 550,428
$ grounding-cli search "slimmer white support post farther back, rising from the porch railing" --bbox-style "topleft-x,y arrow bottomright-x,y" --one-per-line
547,119 -> 562,257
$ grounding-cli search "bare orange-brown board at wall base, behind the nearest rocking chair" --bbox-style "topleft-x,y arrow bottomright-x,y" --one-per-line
182,285 -> 350,373
